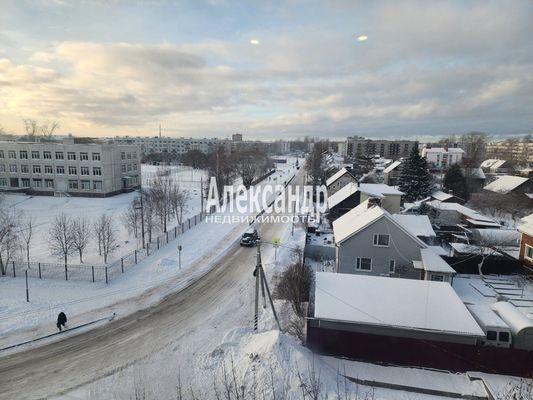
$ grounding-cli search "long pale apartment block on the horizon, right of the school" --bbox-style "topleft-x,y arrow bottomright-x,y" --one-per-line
113,136 -> 229,155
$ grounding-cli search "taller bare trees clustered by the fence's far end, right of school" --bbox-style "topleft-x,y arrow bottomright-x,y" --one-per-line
123,171 -> 189,242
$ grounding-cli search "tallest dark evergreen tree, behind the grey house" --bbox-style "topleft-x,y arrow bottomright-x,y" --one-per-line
398,145 -> 433,202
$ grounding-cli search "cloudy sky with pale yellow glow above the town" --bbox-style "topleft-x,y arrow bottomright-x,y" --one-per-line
0,0 -> 533,139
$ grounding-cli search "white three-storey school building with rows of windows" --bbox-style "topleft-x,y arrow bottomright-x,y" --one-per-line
0,137 -> 141,197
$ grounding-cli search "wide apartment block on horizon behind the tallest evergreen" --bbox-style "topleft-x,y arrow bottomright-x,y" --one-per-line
341,136 -> 418,160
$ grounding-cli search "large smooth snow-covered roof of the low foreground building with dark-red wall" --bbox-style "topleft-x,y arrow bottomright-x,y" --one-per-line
315,272 -> 484,336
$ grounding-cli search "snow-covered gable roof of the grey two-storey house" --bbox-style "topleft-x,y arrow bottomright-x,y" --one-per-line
333,200 -> 427,248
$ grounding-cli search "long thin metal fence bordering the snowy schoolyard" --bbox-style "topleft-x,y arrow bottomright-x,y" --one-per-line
6,213 -> 204,283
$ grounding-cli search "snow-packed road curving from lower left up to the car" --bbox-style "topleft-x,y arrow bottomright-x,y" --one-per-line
0,170 -> 302,400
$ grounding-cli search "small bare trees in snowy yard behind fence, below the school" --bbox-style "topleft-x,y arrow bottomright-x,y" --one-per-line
48,213 -> 118,265
